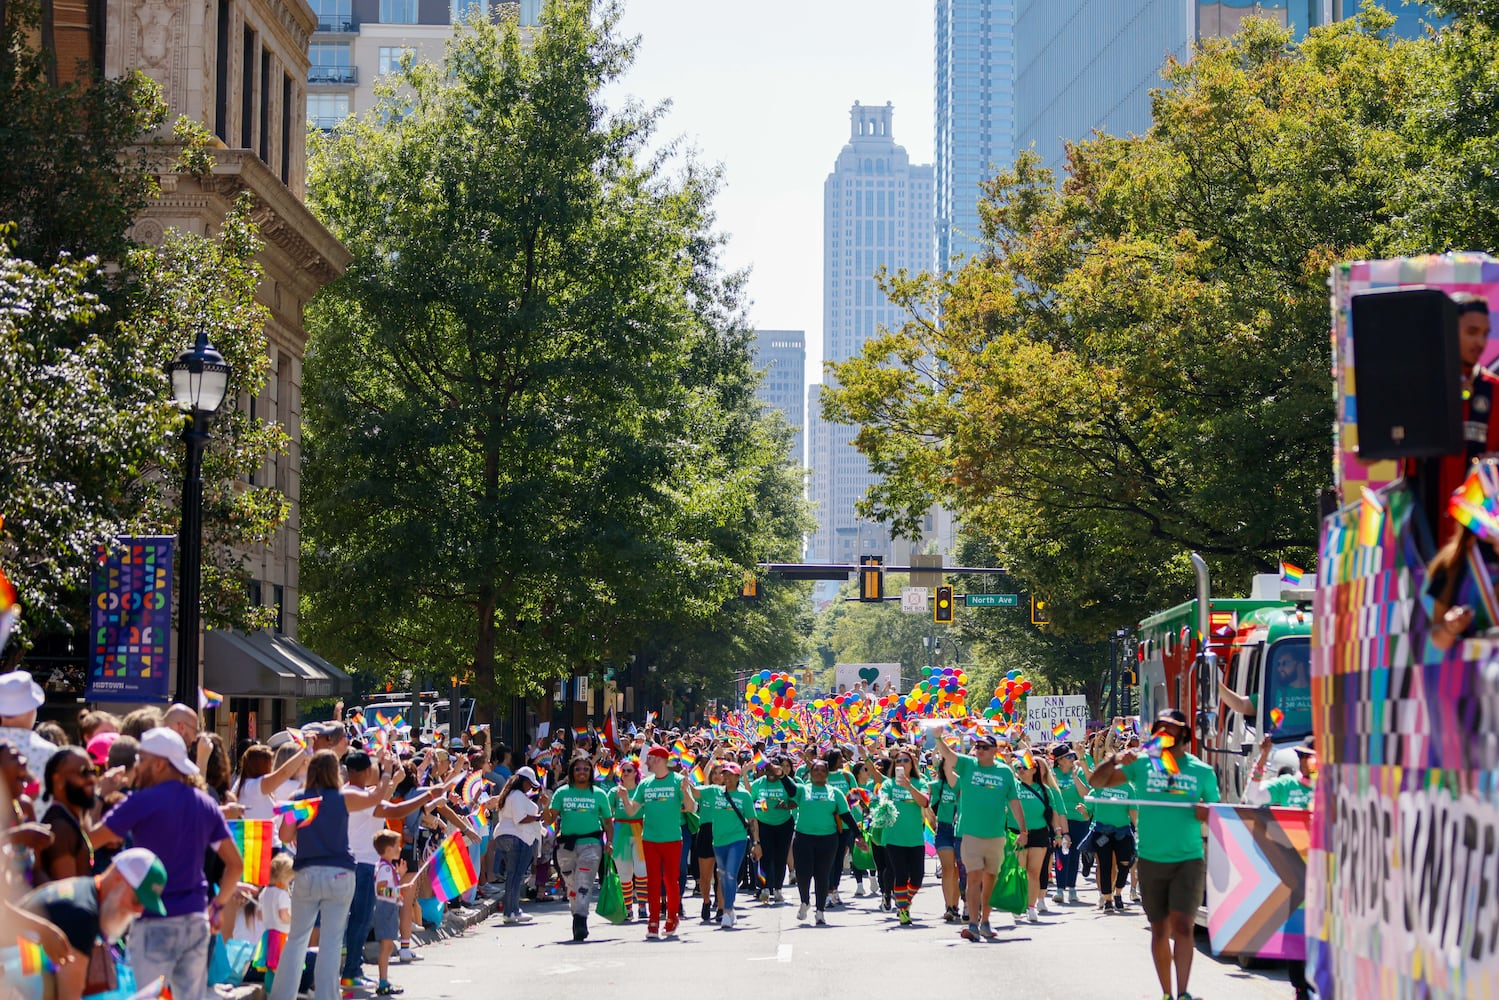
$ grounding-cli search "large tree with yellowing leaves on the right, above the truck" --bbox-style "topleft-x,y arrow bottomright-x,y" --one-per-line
823,10 -> 1430,640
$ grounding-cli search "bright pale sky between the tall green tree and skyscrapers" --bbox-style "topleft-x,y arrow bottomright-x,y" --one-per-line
607,0 -> 932,382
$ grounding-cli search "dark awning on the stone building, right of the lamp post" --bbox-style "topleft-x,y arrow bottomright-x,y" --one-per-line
202,628 -> 354,699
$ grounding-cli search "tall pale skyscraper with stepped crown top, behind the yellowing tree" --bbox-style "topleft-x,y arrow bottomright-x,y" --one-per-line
808,103 -> 932,562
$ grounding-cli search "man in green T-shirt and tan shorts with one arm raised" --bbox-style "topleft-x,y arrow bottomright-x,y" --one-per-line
937,733 -> 1030,942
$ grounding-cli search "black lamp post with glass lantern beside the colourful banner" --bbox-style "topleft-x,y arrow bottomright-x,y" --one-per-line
166,330 -> 229,709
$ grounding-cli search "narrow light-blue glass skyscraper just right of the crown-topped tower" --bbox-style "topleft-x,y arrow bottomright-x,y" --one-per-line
932,0 -> 1019,270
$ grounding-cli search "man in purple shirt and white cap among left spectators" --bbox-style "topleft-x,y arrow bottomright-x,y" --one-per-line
90,727 -> 244,1000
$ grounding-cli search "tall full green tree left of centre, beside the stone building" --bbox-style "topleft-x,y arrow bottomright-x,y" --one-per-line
303,0 -> 800,704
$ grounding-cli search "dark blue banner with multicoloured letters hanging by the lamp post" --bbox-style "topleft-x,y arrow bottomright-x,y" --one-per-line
85,535 -> 177,702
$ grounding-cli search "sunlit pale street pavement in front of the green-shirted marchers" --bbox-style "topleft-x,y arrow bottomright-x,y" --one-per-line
392,880 -> 1291,1000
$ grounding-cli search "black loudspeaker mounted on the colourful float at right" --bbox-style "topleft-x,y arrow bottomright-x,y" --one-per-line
1352,288 -> 1463,462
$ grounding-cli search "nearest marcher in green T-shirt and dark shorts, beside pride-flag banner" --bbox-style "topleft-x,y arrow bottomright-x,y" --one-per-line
1093,709 -> 1219,1000
